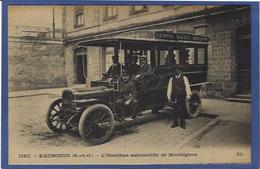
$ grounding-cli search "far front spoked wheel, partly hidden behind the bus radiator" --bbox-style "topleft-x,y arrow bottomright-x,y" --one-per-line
46,99 -> 71,133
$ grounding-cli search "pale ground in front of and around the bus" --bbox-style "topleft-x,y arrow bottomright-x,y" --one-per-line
9,88 -> 251,163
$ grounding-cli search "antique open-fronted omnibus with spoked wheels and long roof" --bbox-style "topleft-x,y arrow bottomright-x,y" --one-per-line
47,30 -> 209,145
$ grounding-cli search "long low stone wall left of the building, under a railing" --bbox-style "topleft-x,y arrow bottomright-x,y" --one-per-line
8,38 -> 66,91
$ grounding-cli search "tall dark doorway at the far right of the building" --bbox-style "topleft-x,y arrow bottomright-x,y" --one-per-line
236,25 -> 251,94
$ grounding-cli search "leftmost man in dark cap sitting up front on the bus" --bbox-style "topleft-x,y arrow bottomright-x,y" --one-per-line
103,56 -> 121,79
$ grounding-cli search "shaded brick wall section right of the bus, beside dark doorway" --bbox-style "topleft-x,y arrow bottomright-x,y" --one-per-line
207,10 -> 250,97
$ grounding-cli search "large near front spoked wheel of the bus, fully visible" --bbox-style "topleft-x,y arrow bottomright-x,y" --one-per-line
79,104 -> 114,145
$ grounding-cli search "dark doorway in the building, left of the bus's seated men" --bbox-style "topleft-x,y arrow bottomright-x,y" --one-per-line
74,47 -> 87,84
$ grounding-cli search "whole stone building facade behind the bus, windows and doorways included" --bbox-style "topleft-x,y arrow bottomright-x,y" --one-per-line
63,5 -> 251,97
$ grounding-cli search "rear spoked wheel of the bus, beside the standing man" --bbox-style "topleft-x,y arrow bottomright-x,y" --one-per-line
186,91 -> 201,118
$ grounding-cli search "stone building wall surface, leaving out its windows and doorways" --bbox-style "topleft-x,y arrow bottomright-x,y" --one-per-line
62,6 -> 250,97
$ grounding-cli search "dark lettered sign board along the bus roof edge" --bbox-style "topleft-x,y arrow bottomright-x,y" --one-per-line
154,31 -> 209,42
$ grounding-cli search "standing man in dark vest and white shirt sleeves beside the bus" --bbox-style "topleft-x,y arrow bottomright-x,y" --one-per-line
167,68 -> 191,129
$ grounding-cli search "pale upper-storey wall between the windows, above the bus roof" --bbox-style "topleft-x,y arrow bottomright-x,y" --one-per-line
65,5 -> 216,40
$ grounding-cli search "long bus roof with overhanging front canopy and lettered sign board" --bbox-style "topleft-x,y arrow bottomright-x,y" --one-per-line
79,30 -> 209,49
